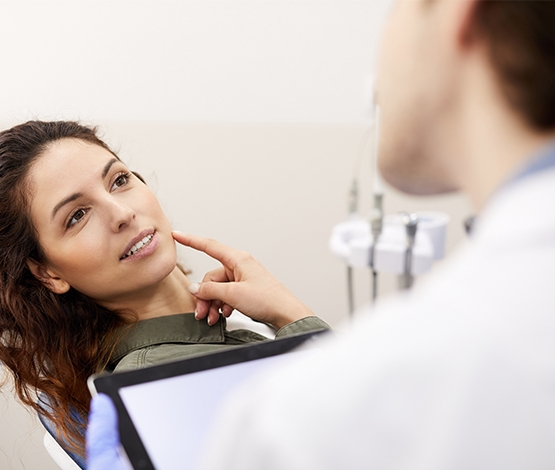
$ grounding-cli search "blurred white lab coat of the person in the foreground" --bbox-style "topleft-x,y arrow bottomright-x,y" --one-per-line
198,169 -> 555,470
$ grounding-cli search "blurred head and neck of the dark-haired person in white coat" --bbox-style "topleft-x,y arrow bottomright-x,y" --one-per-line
377,0 -> 555,206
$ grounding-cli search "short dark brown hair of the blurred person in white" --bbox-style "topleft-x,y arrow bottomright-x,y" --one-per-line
473,0 -> 555,130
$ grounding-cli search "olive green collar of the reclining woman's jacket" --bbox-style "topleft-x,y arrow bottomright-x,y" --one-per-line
110,313 -> 226,364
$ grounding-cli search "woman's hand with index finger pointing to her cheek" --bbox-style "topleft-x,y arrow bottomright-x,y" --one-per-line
173,232 -> 314,329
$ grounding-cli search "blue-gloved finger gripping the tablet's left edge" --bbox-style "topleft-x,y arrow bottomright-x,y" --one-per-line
87,394 -> 129,470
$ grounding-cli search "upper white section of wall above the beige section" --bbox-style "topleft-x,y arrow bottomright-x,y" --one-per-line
0,0 -> 386,123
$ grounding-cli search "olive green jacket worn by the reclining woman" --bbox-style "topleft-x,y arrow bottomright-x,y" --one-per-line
107,313 -> 330,372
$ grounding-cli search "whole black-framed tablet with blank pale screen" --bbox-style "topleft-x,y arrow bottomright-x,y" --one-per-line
88,331 -> 328,470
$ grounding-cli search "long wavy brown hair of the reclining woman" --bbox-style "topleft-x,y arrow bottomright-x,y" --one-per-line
0,121 -> 124,455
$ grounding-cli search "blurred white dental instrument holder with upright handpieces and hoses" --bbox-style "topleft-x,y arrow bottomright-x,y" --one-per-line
329,97 -> 449,314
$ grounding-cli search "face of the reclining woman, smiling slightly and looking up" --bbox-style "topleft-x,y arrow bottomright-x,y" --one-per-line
28,139 -> 176,306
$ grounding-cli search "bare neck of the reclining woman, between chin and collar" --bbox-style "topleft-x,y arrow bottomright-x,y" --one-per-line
99,266 -> 196,321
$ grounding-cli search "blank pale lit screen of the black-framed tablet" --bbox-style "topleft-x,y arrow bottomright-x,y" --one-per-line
119,352 -> 305,470
